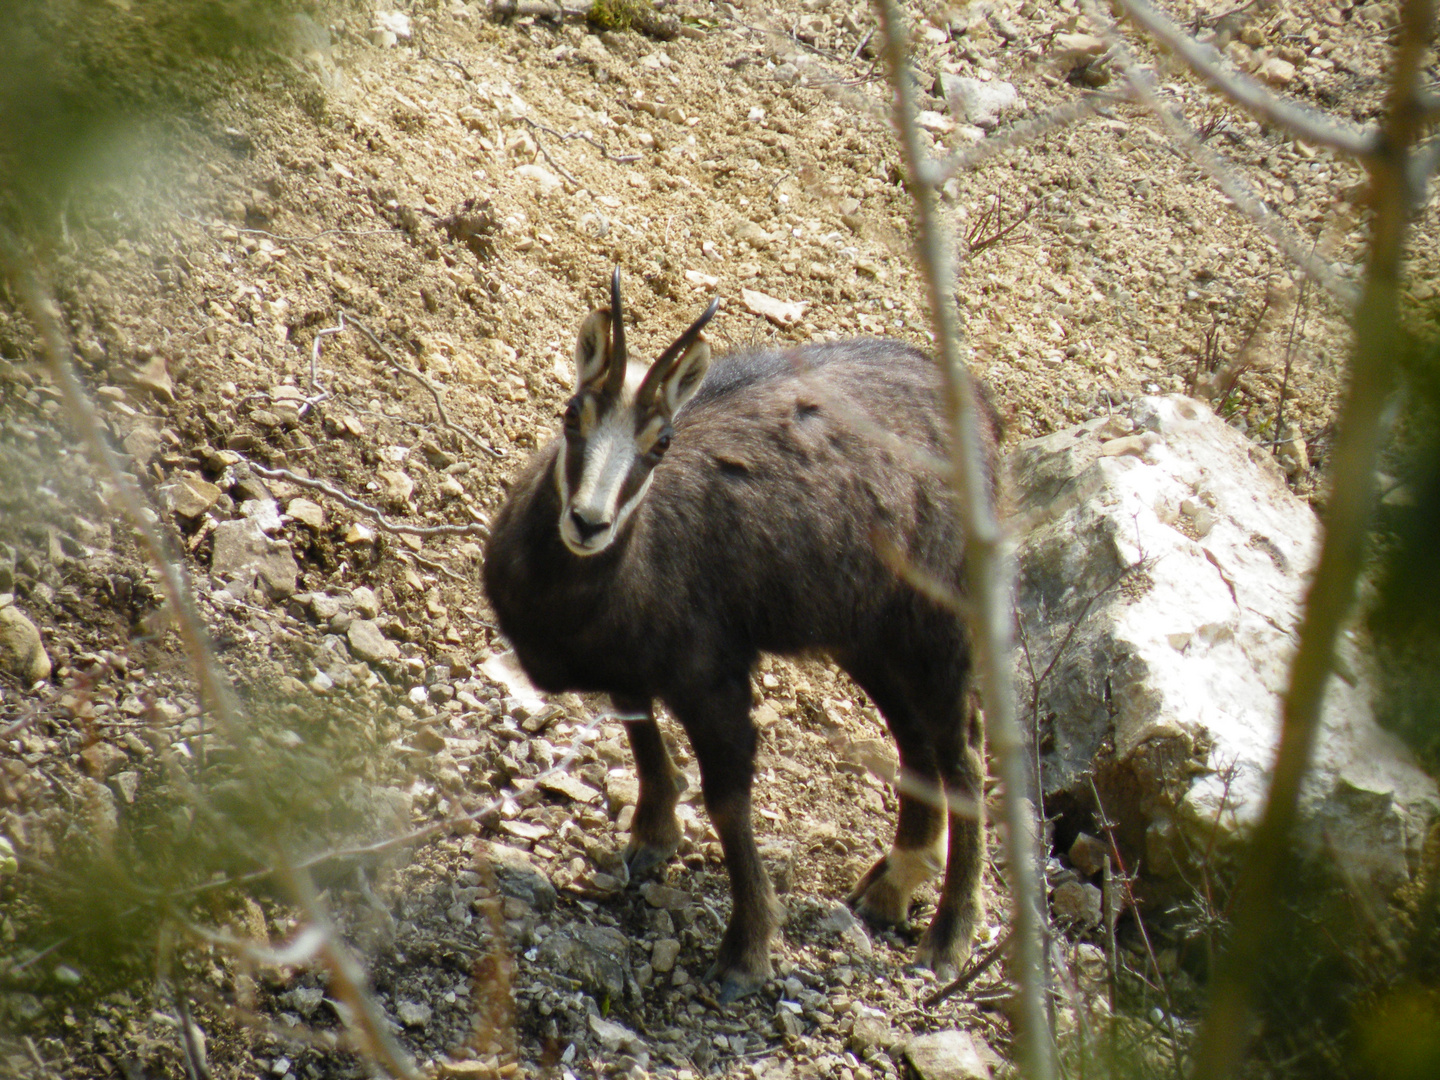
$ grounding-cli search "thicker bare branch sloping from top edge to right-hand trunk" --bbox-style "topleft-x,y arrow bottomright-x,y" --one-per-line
1119,0 -> 1380,160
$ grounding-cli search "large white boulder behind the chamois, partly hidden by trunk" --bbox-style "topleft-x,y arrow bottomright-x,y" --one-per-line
1005,396 -> 1440,896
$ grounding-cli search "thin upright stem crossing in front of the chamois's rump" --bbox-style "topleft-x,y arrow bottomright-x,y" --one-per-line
876,0 -> 1054,1080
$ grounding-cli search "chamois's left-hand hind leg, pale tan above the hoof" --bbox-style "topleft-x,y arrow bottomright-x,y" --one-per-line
848,670 -> 946,926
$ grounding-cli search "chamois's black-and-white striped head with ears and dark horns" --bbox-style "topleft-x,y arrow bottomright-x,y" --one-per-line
554,268 -> 720,556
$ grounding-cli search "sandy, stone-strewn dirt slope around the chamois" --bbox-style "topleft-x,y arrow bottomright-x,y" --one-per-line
0,0 -> 1436,1080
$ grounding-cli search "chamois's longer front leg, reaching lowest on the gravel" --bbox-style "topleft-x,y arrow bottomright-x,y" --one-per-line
665,671 -> 780,1004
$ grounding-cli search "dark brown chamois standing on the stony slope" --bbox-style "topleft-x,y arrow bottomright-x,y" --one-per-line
484,269 -> 996,1002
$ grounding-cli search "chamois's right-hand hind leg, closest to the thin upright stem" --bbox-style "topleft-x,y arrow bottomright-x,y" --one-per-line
916,691 -> 985,978
